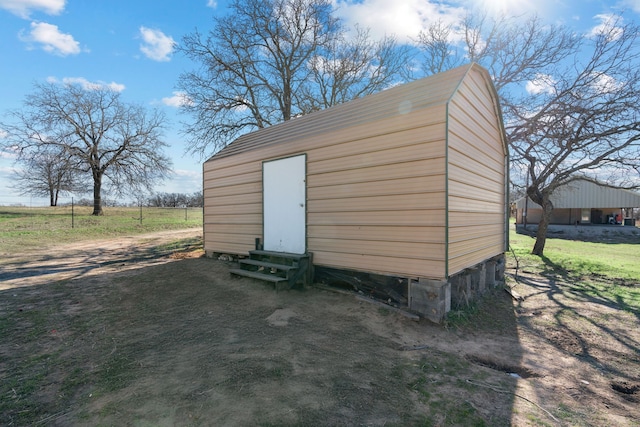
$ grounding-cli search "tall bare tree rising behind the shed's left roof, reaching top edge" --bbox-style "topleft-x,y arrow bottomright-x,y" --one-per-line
177,0 -> 408,156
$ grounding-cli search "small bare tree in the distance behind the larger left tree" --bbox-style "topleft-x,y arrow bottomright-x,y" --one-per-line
14,150 -> 80,206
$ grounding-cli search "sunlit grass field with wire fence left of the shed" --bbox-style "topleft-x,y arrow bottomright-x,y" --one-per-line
0,206 -> 202,253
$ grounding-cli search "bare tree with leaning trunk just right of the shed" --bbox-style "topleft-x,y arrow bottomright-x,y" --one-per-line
420,13 -> 640,255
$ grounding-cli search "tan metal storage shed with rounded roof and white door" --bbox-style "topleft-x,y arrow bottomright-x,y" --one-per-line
204,64 -> 508,317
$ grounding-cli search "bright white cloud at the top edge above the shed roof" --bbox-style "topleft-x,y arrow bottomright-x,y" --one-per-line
333,0 -> 465,42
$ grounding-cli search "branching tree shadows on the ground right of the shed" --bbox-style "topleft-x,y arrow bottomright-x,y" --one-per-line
517,256 -> 640,382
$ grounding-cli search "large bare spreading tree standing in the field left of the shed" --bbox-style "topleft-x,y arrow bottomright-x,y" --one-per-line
2,83 -> 171,215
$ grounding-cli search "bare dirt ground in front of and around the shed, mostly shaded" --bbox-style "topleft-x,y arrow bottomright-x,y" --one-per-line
0,230 -> 640,426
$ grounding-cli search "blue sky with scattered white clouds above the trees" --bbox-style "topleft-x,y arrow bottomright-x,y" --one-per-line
0,0 -> 640,205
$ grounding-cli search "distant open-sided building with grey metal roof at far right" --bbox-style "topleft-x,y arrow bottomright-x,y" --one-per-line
516,179 -> 640,225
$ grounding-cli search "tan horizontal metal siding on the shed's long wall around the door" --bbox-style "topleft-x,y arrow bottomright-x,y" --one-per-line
204,105 -> 446,277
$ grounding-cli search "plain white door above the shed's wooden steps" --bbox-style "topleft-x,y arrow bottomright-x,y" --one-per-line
262,154 -> 307,254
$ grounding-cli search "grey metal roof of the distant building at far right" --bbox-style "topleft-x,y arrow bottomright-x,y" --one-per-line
516,179 -> 640,209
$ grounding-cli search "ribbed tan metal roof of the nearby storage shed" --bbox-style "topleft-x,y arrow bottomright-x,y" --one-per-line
209,63 -> 499,160
